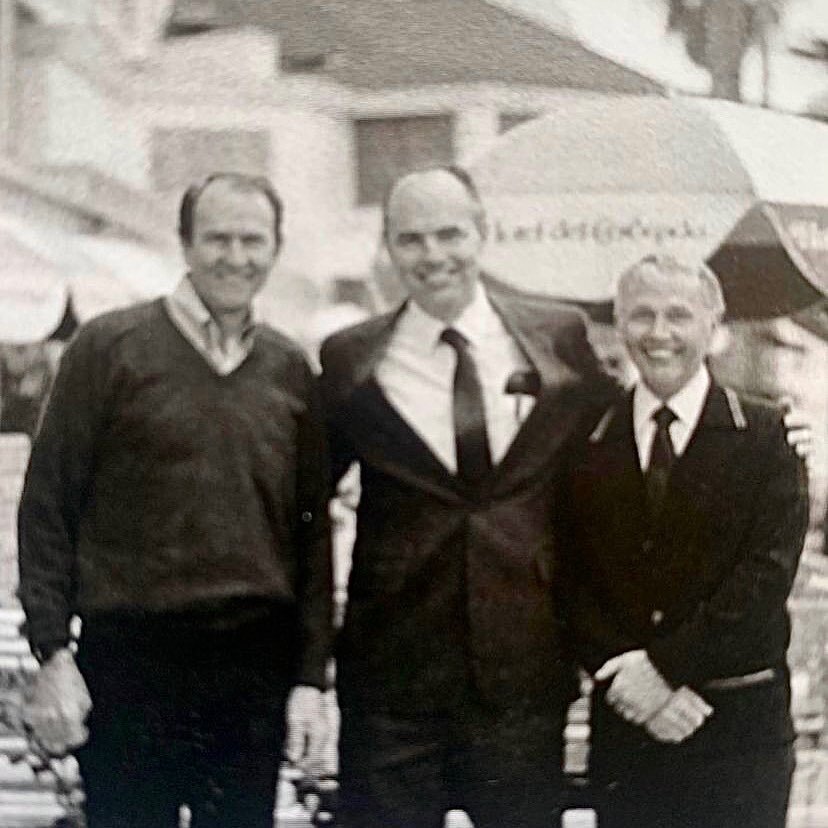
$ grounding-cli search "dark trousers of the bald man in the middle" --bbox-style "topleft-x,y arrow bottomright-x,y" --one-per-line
340,698 -> 564,828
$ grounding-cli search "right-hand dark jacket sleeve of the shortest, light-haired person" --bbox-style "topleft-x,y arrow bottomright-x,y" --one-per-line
648,412 -> 808,686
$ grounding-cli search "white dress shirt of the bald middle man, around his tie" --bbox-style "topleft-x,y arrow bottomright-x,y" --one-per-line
376,285 -> 534,472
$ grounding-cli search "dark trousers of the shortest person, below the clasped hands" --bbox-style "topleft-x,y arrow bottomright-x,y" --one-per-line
590,692 -> 794,828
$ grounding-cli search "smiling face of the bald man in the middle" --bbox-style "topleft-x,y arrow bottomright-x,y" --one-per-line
385,170 -> 483,323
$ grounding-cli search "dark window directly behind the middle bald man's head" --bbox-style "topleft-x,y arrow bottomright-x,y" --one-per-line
354,115 -> 454,204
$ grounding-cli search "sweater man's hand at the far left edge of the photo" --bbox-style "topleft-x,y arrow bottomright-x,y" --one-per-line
23,649 -> 92,756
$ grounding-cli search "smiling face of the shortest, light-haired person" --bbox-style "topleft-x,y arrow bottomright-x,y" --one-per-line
616,267 -> 719,400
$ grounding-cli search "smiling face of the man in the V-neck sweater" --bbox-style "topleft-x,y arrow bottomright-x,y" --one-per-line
184,181 -> 278,317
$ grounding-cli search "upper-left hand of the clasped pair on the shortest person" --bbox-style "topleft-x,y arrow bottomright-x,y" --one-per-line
595,650 -> 673,725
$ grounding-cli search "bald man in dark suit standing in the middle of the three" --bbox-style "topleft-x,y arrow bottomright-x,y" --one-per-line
321,168 -> 612,828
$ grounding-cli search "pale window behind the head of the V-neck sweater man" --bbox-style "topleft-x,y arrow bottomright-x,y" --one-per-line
152,129 -> 270,192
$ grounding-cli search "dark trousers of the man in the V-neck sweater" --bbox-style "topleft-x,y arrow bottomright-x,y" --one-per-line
73,615 -> 296,828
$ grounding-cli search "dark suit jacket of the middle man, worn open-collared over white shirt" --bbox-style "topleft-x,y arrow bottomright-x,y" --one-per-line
321,279 -> 611,711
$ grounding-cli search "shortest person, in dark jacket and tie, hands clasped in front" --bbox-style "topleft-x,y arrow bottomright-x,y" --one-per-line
558,257 -> 807,828
